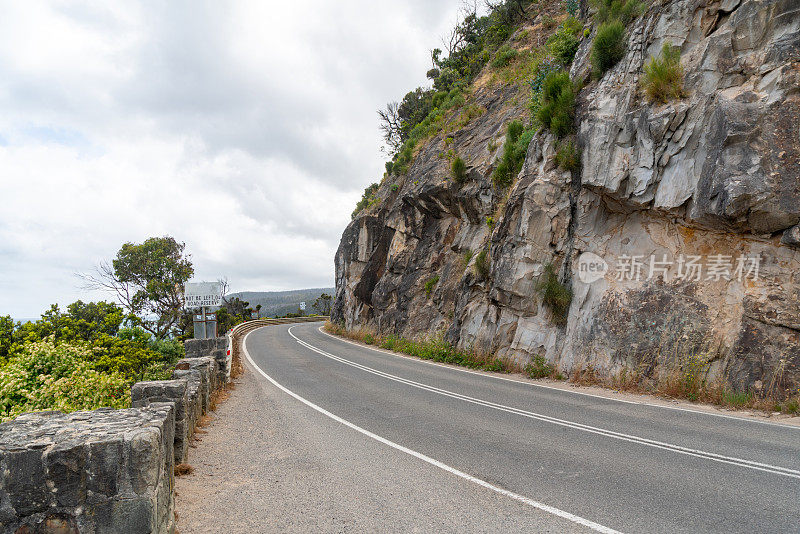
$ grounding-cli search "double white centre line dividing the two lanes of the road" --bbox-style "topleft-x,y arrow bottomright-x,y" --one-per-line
287,327 -> 800,479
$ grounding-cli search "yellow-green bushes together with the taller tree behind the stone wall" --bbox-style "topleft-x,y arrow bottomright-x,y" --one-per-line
0,236 -> 216,421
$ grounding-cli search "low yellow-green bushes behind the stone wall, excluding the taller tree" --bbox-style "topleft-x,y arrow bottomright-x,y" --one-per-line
0,301 -> 184,421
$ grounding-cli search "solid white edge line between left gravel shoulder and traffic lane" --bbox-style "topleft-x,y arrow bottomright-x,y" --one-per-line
242,327 -> 622,534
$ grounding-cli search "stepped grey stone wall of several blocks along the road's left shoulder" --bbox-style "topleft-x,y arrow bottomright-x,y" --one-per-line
0,337 -> 230,534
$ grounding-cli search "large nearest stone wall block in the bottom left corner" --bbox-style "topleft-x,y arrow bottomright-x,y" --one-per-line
0,403 -> 174,534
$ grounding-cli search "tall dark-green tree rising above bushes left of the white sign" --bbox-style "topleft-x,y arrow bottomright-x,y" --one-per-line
82,236 -> 194,339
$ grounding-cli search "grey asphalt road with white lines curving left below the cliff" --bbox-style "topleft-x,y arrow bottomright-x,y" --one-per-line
242,323 -> 800,533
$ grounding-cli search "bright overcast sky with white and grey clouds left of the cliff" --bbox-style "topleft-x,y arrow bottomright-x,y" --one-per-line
0,0 -> 460,317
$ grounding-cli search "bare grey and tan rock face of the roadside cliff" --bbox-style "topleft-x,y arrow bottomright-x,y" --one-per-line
333,0 -> 800,391
